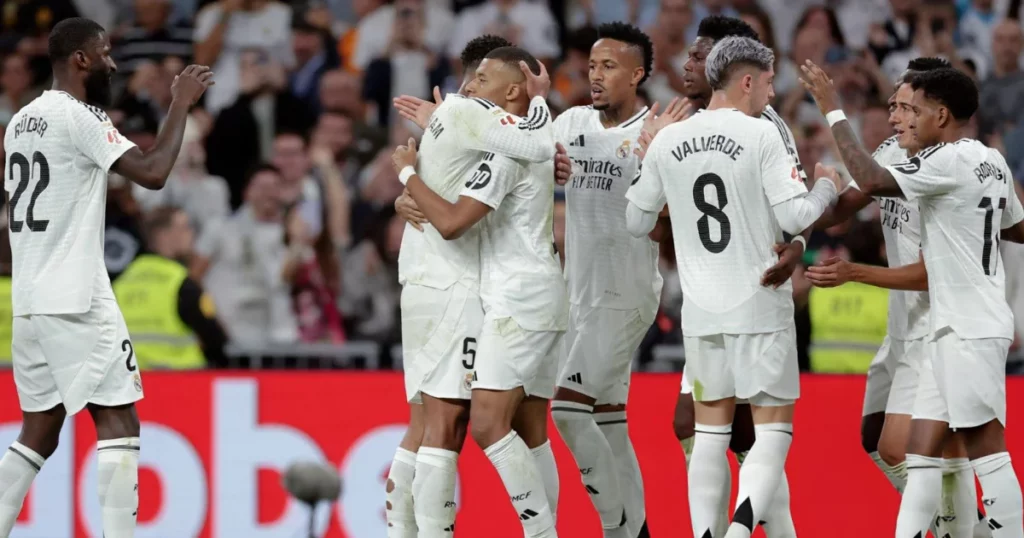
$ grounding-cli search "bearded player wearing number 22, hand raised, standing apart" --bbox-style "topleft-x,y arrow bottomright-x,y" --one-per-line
0,17 -> 213,538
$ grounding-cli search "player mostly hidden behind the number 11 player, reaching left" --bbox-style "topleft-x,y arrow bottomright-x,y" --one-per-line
806,57 -> 991,537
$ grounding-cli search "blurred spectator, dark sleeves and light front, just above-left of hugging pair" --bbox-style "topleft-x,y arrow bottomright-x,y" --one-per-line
362,2 -> 449,126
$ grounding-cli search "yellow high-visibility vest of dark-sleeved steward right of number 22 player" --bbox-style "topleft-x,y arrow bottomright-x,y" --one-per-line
114,254 -> 206,369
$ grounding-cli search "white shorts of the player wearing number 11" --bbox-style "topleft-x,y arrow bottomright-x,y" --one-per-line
913,328 -> 1011,429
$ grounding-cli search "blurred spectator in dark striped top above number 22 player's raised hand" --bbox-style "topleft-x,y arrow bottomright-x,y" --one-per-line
113,0 -> 193,76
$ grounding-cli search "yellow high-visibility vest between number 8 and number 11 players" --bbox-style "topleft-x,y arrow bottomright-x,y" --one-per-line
809,282 -> 889,373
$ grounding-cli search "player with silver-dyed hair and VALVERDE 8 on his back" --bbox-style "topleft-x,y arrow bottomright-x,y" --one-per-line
626,37 -> 840,538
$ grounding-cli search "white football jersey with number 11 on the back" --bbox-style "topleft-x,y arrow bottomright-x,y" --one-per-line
886,138 -> 1024,339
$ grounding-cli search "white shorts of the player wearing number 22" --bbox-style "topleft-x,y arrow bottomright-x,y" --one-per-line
11,298 -> 142,415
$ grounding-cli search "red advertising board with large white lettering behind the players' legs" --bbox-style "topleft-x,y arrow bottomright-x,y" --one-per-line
0,372 -> 1024,538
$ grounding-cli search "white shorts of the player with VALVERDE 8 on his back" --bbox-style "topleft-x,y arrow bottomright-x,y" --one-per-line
682,327 -> 800,406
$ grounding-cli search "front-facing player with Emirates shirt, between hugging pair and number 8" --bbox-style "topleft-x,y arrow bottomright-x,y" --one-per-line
551,23 -> 667,538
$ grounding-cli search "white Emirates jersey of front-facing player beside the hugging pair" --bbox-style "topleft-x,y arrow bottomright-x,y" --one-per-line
554,107 -> 663,323
